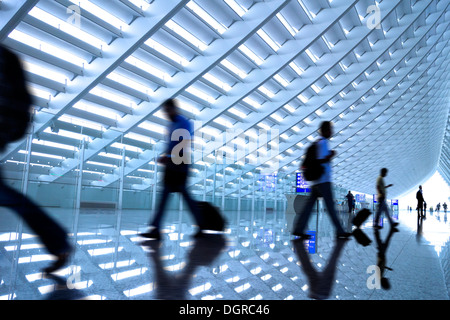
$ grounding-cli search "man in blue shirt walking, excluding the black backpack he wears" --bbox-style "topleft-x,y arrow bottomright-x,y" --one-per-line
292,121 -> 350,239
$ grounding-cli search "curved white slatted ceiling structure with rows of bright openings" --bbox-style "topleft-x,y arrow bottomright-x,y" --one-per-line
0,0 -> 450,197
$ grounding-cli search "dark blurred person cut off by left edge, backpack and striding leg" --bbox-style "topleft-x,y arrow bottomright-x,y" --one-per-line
0,45 -> 72,273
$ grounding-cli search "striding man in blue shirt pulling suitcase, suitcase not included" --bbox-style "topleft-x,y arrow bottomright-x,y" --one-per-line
140,99 -> 202,240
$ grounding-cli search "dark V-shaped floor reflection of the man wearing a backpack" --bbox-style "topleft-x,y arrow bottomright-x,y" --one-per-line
292,239 -> 348,300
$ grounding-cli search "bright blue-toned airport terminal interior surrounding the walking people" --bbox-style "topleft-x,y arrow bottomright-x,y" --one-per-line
0,0 -> 450,301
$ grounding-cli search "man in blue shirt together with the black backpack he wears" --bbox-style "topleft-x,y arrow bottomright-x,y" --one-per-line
292,121 -> 350,240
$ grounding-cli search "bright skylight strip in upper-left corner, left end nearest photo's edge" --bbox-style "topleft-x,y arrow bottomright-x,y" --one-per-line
8,29 -> 88,67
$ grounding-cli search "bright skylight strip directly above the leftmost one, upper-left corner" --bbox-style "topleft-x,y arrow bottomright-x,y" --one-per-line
28,7 -> 108,49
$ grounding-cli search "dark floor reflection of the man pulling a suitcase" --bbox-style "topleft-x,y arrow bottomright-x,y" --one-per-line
142,234 -> 225,300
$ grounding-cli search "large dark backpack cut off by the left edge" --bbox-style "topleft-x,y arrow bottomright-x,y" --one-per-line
0,45 -> 32,148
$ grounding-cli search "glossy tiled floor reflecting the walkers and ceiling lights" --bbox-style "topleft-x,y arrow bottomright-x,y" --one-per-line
0,205 -> 450,300
